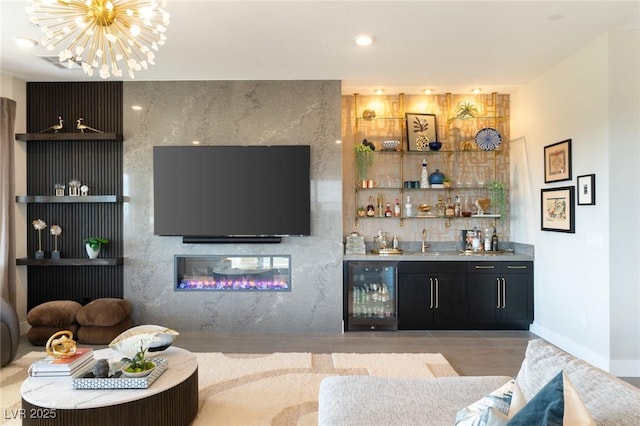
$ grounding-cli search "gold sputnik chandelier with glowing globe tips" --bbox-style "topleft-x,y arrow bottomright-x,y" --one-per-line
27,0 -> 169,79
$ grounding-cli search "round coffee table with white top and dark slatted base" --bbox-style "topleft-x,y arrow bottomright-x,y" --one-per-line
20,346 -> 198,426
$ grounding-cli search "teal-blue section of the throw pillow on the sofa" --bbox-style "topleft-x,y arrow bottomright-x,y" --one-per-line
507,371 -> 564,426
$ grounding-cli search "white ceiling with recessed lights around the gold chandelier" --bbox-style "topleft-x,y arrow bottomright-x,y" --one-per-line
0,0 -> 640,94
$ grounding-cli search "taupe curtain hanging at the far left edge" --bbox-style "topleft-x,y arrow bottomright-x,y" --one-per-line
0,98 -> 16,308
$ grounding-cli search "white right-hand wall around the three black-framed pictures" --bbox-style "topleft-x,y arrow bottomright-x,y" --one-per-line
511,30 -> 640,376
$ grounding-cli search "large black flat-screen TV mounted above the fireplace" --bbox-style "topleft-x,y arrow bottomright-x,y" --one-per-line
153,145 -> 311,237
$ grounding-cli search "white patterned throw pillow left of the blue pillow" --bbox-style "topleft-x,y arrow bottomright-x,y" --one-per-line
455,378 -> 516,426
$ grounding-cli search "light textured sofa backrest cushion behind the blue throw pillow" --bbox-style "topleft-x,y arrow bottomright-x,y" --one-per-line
516,339 -> 640,426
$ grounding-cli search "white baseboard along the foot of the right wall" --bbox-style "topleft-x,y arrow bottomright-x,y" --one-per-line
530,322 -> 640,377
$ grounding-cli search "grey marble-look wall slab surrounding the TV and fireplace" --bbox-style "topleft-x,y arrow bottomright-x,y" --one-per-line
123,81 -> 343,333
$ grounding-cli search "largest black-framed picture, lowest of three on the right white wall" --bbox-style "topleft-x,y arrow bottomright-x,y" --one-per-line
540,186 -> 576,234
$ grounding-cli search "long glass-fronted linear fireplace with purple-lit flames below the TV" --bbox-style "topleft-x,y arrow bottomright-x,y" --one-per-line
175,255 -> 291,292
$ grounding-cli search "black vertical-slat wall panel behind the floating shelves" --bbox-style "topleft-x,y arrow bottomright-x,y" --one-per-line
27,82 -> 124,309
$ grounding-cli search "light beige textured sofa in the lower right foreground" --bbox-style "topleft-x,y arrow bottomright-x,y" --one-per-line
318,339 -> 640,426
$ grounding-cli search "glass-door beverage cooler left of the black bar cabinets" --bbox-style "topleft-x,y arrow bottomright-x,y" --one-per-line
343,261 -> 398,331
